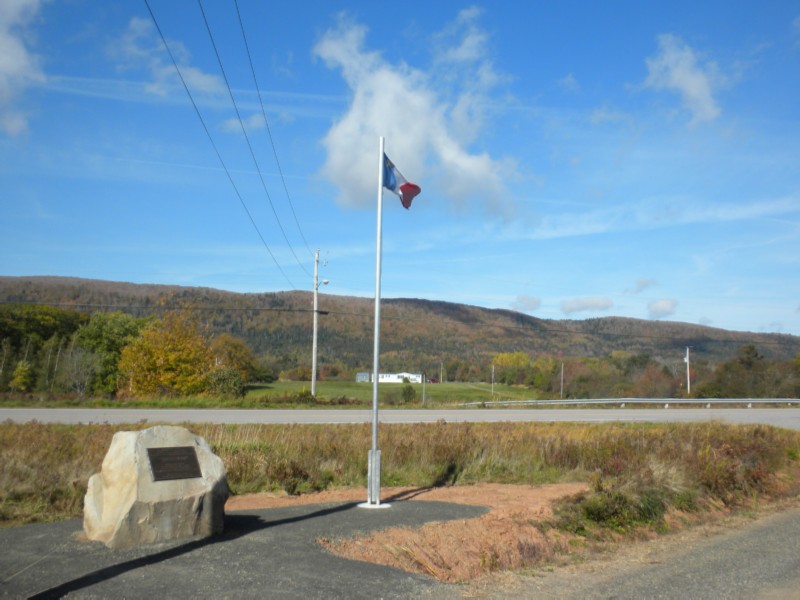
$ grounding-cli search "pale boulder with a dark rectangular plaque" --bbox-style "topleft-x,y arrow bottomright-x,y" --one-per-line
83,426 -> 229,548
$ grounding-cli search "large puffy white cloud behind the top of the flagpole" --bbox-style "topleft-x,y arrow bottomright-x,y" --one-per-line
314,9 -> 516,213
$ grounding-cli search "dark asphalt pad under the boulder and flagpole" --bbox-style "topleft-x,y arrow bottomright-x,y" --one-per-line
0,499 -> 486,600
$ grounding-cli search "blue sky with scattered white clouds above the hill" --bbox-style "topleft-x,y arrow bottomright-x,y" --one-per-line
0,0 -> 800,335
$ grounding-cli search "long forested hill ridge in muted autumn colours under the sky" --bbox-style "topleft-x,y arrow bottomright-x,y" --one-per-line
0,277 -> 800,372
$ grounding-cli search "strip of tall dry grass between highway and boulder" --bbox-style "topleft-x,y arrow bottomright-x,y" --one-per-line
0,423 -> 800,535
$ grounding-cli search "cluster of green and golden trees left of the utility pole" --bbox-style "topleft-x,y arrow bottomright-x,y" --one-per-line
0,305 -> 272,397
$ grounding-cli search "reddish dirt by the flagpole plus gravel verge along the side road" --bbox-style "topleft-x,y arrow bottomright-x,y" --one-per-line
226,483 -> 800,600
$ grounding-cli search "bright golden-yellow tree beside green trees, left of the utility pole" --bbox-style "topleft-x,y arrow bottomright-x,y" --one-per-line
119,310 -> 214,396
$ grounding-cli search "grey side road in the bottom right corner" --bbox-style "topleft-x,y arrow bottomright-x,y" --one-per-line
512,509 -> 800,600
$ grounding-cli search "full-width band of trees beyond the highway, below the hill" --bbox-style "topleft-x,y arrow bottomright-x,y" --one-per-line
0,305 -> 800,398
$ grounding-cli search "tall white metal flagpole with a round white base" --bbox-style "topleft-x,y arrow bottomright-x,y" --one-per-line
359,137 -> 390,508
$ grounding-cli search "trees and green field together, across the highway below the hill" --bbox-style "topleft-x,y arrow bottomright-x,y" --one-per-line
0,304 -> 800,407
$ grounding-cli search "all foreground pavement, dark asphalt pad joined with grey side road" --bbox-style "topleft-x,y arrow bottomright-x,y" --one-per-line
0,501 -> 800,600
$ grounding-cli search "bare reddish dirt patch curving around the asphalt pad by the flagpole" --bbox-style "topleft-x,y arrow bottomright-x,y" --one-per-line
225,483 -> 588,582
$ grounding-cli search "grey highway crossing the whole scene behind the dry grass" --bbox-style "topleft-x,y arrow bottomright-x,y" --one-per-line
0,408 -> 800,430
